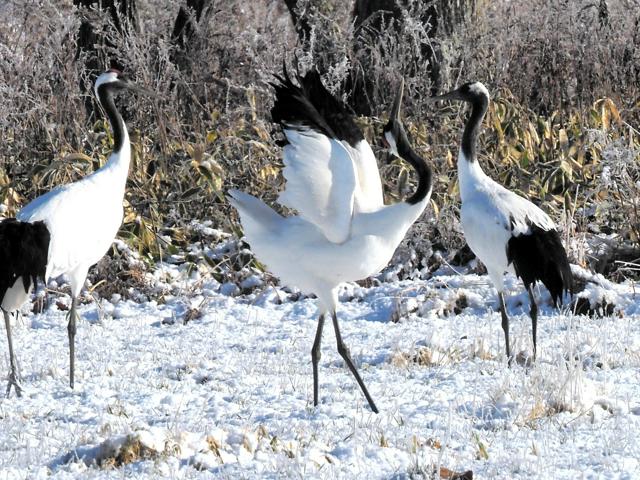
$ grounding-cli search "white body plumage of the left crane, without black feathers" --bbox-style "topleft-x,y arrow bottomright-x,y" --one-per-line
17,135 -> 131,296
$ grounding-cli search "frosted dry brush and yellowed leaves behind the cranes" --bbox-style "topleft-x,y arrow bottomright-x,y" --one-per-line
0,0 -> 640,292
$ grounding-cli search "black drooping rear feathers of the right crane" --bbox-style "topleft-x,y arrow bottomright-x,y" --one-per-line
507,224 -> 573,306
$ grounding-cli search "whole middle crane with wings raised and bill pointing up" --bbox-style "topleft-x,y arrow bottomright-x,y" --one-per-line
229,70 -> 431,413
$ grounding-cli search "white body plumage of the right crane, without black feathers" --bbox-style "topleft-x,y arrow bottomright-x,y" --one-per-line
458,152 -> 555,291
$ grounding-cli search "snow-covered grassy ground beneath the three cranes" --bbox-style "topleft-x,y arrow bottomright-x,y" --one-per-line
0,238 -> 640,479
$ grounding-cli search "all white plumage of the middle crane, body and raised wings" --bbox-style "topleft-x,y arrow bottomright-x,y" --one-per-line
229,129 -> 430,311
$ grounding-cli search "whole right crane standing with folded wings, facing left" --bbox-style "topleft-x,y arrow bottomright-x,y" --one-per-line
431,82 -> 573,363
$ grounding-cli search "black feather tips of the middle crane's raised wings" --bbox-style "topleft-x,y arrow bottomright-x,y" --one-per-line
271,68 -> 364,146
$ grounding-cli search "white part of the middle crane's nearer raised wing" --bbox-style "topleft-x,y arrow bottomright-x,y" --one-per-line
278,127 -> 356,243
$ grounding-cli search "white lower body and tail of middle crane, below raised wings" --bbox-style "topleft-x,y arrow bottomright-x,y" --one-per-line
230,190 -> 424,302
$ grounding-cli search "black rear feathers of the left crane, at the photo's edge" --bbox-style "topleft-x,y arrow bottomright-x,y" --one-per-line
0,218 -> 51,303
